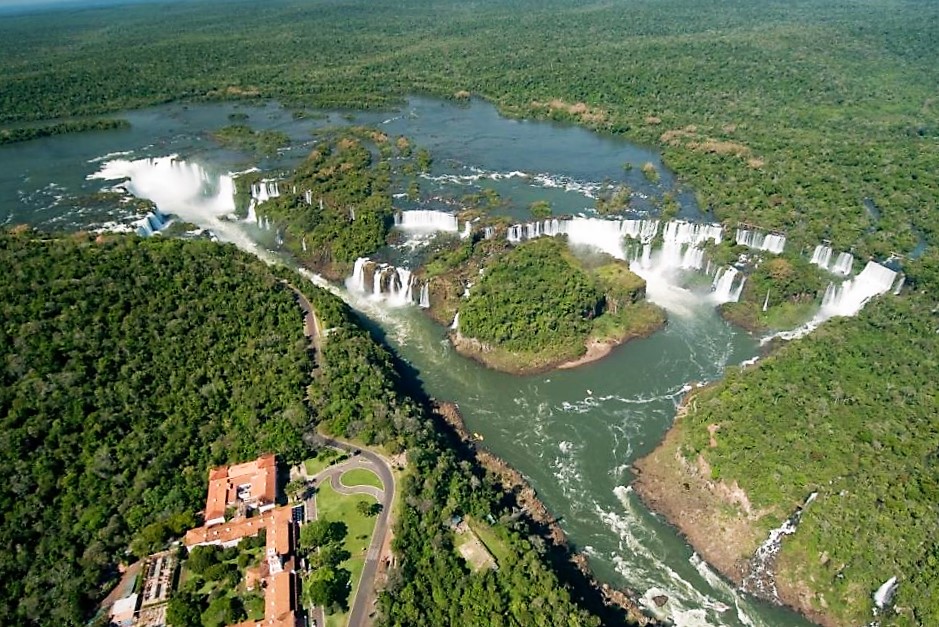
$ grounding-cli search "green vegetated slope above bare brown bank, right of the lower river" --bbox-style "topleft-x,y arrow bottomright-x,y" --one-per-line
676,293 -> 939,625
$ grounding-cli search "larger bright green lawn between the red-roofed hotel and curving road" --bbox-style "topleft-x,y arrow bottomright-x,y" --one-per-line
316,484 -> 375,627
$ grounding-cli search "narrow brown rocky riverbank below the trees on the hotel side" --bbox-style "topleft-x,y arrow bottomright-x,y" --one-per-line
433,402 -> 655,625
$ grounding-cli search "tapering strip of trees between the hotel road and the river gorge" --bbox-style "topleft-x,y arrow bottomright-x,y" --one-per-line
286,288 -> 622,627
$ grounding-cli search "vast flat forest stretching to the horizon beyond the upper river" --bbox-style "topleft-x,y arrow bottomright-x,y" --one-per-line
0,0 -> 939,257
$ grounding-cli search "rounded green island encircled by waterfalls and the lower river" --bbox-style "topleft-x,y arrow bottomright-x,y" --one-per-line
454,238 -> 664,372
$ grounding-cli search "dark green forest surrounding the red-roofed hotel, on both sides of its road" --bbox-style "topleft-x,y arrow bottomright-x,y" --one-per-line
0,229 -> 612,625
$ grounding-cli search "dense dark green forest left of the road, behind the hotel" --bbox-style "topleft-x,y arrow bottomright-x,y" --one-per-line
0,230 -> 311,625
